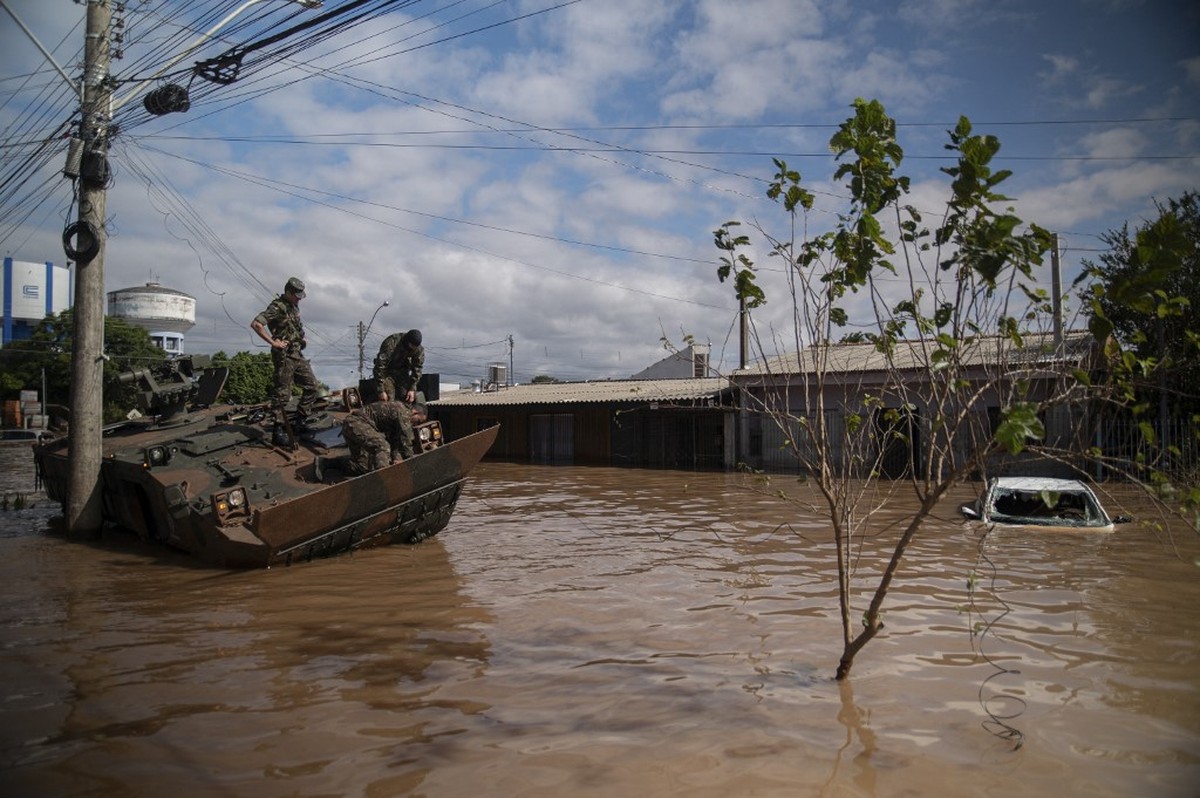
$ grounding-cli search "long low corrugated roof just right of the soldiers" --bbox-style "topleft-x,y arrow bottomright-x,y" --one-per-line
430,377 -> 730,407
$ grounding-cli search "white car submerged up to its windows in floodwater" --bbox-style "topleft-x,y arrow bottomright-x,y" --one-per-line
961,476 -> 1130,532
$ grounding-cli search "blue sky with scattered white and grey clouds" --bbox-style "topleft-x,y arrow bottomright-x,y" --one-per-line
0,0 -> 1200,389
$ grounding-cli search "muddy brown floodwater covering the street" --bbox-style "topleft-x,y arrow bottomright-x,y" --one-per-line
0,448 -> 1200,798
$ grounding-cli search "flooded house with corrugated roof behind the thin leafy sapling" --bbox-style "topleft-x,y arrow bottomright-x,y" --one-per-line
730,331 -> 1096,478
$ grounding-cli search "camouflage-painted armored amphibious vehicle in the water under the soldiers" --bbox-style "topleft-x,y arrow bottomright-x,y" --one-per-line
34,357 -> 498,568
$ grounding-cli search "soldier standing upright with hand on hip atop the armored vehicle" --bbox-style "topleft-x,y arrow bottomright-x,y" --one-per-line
250,277 -> 318,426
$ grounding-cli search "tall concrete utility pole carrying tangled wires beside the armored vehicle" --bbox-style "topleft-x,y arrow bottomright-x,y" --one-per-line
65,0 -> 112,534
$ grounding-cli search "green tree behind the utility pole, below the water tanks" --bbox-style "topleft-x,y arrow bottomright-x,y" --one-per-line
0,310 -> 167,422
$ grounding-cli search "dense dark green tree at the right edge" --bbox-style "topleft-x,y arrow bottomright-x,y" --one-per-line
1081,192 -> 1200,419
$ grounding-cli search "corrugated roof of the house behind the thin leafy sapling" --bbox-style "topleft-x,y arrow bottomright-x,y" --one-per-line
736,330 -> 1092,377
